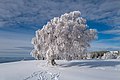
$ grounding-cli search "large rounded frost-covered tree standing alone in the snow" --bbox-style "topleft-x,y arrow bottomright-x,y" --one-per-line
32,11 -> 96,65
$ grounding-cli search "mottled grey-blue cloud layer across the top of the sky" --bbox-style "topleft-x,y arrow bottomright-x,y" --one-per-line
0,0 -> 120,26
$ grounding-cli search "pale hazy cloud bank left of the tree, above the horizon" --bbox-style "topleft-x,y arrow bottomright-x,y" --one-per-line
0,30 -> 33,57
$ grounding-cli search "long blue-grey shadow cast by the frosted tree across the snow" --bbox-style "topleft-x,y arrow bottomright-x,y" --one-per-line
60,60 -> 120,68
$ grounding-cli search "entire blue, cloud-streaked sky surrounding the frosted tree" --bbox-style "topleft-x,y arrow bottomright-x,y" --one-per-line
0,0 -> 120,57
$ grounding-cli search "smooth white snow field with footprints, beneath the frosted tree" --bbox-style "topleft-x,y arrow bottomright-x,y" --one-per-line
0,59 -> 120,80
